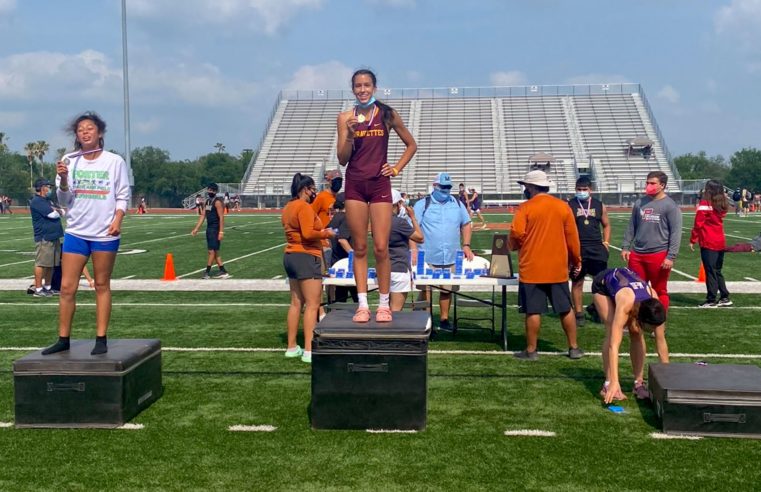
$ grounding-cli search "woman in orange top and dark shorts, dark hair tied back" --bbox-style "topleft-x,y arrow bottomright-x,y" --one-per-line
281,173 -> 336,363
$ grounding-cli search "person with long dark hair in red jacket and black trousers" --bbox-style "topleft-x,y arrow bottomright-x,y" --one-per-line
690,179 -> 732,308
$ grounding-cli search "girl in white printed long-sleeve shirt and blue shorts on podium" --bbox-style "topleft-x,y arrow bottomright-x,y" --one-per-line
42,112 -> 130,355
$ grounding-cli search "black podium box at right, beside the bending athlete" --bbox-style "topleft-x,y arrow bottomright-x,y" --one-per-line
648,364 -> 761,439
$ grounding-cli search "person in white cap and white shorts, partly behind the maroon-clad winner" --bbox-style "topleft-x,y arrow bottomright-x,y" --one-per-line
388,189 -> 423,311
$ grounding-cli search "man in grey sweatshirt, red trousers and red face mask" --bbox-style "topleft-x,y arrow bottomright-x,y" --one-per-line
621,171 -> 682,311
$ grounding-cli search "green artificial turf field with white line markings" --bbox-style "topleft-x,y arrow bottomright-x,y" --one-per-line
0,214 -> 761,491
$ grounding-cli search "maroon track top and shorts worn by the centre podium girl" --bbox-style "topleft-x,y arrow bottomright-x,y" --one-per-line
345,105 -> 391,203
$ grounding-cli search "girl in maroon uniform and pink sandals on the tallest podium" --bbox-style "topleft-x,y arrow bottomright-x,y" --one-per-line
336,69 -> 417,323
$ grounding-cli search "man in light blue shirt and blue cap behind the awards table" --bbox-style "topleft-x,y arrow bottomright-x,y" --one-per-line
414,173 -> 473,330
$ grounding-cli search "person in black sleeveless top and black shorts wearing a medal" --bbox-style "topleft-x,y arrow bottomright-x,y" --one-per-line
568,176 -> 610,327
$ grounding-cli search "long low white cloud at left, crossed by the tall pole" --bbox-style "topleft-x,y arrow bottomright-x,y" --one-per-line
0,50 -> 256,107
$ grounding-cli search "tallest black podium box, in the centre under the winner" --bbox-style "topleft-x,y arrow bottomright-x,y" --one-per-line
312,310 -> 430,430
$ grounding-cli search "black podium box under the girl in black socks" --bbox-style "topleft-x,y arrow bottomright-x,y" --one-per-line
13,340 -> 162,428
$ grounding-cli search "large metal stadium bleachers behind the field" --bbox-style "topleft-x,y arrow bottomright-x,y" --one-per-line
241,84 -> 680,198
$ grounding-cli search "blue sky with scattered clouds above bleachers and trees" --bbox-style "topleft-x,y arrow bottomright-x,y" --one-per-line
0,0 -> 761,159
